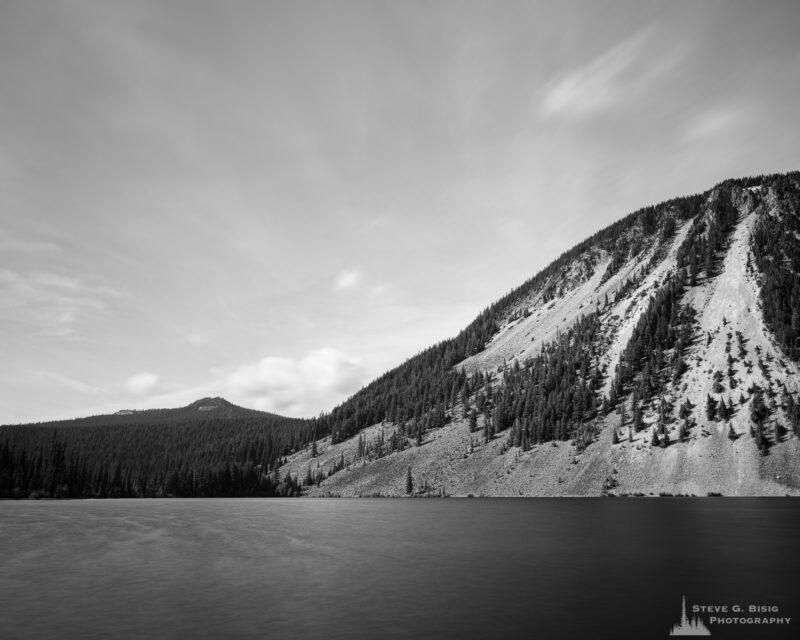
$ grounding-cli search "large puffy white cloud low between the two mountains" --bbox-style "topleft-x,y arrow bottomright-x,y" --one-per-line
225,347 -> 365,416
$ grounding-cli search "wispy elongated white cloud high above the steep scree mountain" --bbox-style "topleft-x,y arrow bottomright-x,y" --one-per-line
539,30 -> 682,119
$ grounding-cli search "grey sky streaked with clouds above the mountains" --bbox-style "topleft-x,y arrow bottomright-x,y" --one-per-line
0,0 -> 800,424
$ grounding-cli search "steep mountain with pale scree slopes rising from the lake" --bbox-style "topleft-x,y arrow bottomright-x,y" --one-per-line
280,172 -> 800,496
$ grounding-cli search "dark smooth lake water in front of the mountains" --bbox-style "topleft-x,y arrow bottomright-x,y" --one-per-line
0,498 -> 800,640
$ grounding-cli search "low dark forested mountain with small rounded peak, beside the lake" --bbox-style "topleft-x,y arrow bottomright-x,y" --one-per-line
0,398 -> 313,498
